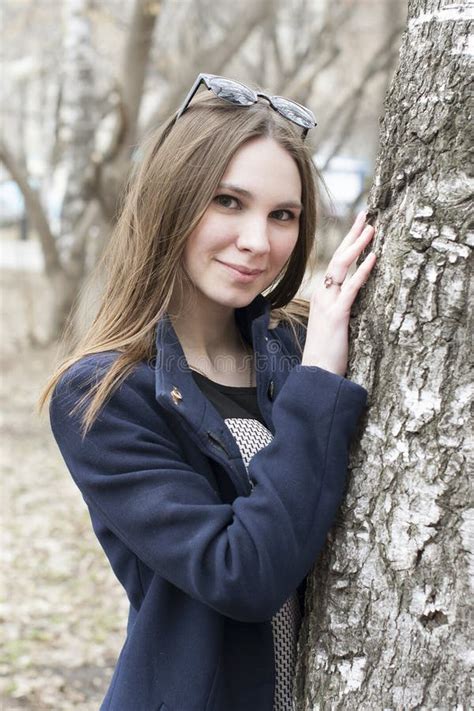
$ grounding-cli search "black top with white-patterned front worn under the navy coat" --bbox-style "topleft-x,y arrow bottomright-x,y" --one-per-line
192,371 -> 301,711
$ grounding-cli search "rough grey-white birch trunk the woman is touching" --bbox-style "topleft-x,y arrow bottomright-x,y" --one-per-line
296,0 -> 473,711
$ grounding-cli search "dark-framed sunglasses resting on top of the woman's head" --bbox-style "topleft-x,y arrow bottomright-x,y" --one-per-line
176,74 -> 317,140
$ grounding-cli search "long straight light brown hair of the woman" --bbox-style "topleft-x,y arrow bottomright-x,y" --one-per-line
39,89 -> 320,434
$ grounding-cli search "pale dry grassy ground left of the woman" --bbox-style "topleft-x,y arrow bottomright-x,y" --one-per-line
0,271 -> 127,711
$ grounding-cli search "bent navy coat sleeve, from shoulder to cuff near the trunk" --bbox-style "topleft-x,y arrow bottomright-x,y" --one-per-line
50,363 -> 367,622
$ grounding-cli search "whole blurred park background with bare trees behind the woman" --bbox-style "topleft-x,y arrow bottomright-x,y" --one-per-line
0,0 -> 407,711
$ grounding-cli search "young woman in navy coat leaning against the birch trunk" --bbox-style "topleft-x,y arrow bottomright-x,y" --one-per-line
40,75 -> 375,711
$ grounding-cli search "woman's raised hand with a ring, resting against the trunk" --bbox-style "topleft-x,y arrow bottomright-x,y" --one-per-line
301,212 -> 376,376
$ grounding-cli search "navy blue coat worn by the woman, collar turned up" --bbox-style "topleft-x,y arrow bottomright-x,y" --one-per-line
50,295 -> 367,711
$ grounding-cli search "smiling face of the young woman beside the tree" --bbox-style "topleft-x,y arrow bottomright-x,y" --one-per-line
184,138 -> 301,308
